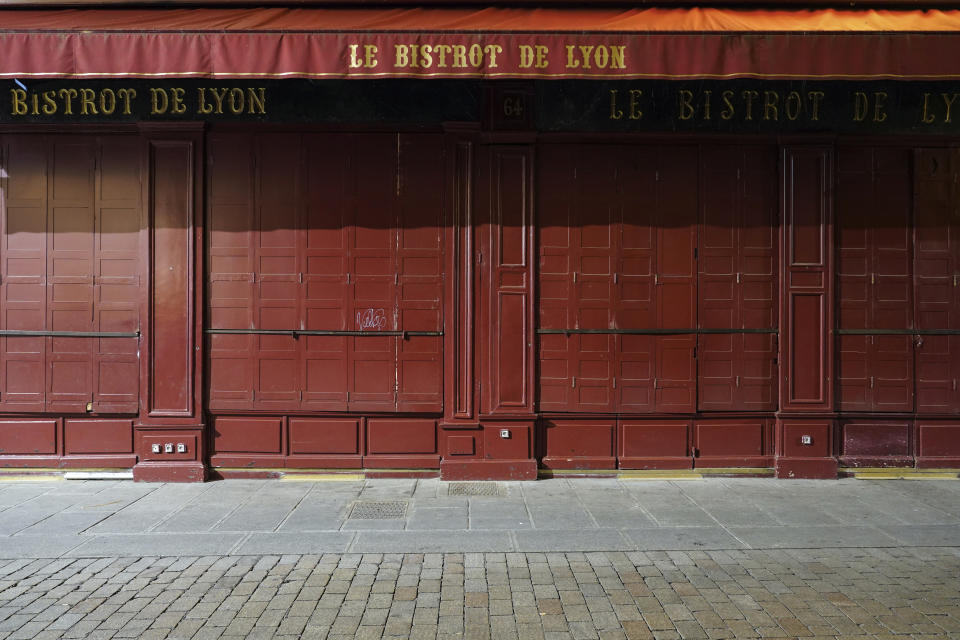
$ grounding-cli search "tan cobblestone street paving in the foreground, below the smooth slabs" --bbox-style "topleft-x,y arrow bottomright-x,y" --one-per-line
0,547 -> 960,640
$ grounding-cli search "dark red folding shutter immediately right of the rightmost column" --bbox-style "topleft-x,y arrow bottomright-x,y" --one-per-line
837,147 -> 914,411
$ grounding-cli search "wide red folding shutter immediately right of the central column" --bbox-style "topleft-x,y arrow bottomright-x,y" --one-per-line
538,145 -> 697,412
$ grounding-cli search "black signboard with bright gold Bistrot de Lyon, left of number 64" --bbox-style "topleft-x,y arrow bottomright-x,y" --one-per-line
0,79 -> 480,124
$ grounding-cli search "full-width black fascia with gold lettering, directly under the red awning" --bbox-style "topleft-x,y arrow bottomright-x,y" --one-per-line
0,79 -> 960,135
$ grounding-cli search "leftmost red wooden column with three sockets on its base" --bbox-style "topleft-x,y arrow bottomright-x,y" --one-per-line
134,124 -> 206,482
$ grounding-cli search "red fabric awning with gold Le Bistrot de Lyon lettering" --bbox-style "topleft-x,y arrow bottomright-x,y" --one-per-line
0,8 -> 960,80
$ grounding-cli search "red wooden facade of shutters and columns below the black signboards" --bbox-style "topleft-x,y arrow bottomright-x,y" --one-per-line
0,125 -> 960,480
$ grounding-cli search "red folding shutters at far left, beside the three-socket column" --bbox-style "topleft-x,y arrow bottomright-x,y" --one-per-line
0,135 -> 143,413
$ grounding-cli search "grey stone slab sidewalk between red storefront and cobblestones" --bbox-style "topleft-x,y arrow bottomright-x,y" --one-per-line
0,478 -> 960,558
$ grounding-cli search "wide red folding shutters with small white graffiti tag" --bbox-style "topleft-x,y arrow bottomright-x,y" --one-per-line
209,134 -> 444,411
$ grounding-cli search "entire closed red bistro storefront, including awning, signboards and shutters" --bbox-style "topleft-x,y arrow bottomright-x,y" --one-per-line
0,2 -> 960,481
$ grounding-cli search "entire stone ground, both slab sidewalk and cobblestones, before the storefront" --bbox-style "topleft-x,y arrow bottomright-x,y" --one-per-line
0,479 -> 960,640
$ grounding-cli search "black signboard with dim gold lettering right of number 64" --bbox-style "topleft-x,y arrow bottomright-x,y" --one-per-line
536,80 -> 960,134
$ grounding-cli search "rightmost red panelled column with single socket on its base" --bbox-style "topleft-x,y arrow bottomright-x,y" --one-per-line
776,147 -> 837,478
